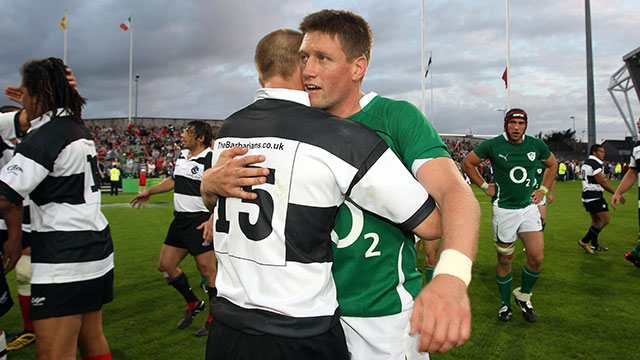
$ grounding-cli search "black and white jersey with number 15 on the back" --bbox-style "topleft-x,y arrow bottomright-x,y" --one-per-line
212,89 -> 435,337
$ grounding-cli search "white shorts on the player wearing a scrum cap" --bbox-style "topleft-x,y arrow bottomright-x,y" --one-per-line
493,204 -> 542,244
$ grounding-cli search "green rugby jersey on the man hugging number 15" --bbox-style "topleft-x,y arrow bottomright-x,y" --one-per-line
333,93 -> 449,317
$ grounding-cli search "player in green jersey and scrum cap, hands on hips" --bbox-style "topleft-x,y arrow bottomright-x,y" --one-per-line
462,109 -> 558,322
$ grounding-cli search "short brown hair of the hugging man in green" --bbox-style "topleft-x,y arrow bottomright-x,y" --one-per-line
300,9 -> 373,61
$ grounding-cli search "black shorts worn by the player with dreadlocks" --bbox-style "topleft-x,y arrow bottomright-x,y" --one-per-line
29,269 -> 113,320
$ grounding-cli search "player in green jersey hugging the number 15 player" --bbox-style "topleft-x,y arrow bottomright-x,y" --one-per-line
203,10 -> 480,359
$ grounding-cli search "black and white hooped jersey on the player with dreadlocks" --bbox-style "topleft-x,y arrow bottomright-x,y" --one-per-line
0,113 -> 113,284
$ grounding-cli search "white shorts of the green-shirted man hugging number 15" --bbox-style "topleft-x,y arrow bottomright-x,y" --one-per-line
340,309 -> 429,360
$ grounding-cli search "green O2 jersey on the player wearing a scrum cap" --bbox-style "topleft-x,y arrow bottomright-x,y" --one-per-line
473,133 -> 551,209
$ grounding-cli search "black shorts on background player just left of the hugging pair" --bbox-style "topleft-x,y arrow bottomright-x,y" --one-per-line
164,214 -> 213,256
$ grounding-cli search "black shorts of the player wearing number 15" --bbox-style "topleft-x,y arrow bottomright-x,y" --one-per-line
205,318 -> 349,360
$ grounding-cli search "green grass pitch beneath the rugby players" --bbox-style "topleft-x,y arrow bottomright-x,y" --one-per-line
2,181 -> 640,360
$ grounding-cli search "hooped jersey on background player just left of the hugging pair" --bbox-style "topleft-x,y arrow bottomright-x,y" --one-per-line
173,148 -> 213,216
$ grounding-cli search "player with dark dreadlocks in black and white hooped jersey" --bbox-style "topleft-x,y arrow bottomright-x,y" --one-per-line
0,58 -> 113,360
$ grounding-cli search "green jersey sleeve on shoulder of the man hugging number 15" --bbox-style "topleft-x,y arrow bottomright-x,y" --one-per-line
389,101 -> 451,169
